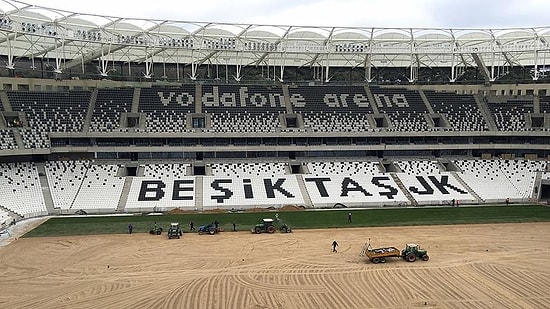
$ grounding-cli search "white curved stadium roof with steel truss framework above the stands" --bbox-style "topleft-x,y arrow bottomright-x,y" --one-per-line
0,0 -> 550,80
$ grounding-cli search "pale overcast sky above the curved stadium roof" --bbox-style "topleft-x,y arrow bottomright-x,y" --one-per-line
10,0 -> 550,28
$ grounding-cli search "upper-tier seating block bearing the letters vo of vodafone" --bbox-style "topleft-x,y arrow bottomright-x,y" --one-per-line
138,85 -> 195,132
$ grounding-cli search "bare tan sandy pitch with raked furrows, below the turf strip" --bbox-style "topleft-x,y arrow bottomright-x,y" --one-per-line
0,223 -> 550,309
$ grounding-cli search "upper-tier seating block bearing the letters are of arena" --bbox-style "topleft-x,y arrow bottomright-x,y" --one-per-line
288,86 -> 372,132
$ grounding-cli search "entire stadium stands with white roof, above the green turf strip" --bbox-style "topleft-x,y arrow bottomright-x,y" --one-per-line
0,1 -> 550,217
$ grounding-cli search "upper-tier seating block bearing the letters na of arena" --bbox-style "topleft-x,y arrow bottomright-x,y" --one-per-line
371,87 -> 430,131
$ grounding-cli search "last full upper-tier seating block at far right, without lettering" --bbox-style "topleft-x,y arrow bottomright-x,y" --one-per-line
487,100 -> 533,131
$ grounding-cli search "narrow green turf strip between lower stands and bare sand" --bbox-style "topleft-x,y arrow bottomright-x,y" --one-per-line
21,205 -> 550,237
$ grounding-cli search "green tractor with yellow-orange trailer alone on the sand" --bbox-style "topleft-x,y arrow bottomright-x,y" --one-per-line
359,239 -> 430,264
